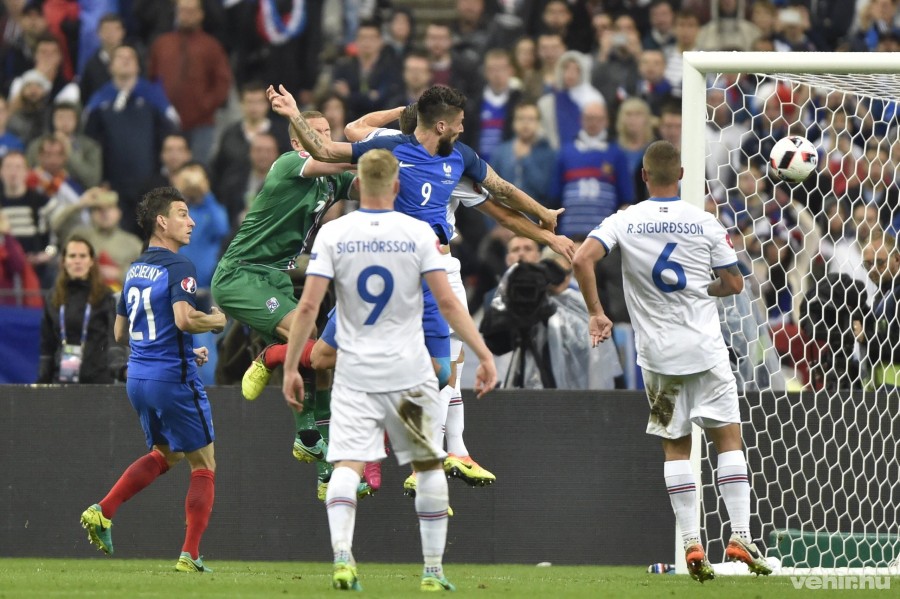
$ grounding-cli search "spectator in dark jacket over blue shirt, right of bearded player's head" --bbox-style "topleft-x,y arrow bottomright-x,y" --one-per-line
461,49 -> 522,162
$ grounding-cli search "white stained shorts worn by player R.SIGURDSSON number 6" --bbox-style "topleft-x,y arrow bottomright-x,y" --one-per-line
641,360 -> 741,439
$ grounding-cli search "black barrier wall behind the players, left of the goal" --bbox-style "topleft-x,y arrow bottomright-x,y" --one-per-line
0,385 -> 674,564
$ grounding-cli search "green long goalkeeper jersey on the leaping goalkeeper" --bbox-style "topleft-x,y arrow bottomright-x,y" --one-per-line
222,151 -> 355,269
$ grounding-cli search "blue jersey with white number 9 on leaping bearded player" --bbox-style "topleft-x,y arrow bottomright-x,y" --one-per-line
352,135 -> 487,244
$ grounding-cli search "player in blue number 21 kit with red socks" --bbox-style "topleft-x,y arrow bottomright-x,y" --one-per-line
81,187 -> 225,572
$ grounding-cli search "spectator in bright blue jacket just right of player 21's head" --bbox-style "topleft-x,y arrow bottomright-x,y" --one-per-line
172,162 -> 230,292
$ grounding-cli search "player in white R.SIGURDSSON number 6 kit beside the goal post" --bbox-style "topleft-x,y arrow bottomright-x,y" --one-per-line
573,141 -> 771,582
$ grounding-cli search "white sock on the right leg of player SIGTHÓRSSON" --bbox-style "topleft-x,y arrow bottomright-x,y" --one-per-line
416,469 -> 450,578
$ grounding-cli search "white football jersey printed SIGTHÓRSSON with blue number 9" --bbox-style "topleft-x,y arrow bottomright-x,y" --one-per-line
306,209 -> 444,393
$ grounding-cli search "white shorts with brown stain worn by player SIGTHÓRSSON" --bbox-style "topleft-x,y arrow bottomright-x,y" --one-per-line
327,382 -> 447,465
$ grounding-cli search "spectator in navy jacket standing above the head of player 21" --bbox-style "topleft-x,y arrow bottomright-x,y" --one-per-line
84,45 -> 178,232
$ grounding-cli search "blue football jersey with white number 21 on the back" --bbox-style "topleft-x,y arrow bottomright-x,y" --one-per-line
117,247 -> 197,383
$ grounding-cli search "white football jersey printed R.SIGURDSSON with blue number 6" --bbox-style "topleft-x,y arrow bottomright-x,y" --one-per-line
590,197 -> 737,375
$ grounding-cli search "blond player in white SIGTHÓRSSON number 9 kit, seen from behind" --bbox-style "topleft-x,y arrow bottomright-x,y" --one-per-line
283,150 -> 497,591
